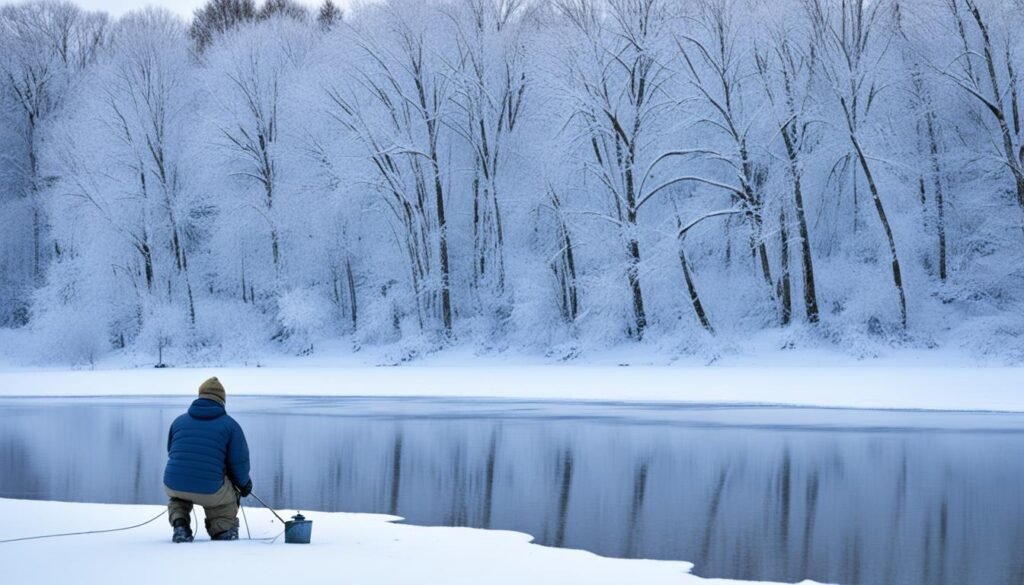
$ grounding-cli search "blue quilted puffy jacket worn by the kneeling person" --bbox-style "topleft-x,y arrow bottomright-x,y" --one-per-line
164,399 -> 249,494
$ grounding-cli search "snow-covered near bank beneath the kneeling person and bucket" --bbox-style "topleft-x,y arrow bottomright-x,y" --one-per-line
0,499 -> 812,585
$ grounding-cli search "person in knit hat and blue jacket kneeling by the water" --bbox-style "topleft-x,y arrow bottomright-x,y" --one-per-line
164,378 -> 253,542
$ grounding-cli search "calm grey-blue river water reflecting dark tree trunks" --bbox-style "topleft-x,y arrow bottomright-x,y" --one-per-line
0,398 -> 1024,585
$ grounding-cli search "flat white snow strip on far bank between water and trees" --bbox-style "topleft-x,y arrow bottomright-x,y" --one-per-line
0,365 -> 1024,412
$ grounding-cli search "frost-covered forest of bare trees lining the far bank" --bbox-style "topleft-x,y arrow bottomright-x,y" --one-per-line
0,0 -> 1024,362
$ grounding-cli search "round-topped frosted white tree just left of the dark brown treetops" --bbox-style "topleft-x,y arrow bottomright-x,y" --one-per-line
41,9 -> 198,352
